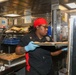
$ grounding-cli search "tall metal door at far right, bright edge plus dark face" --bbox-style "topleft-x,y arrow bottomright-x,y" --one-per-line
68,15 -> 76,75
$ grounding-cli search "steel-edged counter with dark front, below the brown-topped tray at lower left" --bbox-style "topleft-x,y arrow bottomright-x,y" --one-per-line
0,60 -> 25,75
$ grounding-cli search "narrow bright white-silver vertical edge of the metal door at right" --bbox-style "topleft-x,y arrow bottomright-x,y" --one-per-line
67,17 -> 73,75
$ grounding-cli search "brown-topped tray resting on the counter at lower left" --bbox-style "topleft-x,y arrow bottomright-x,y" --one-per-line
0,53 -> 25,65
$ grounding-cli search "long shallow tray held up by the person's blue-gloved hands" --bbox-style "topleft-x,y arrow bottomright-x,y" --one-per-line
34,42 -> 68,46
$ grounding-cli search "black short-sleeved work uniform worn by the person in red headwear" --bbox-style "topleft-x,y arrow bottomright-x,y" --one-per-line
19,32 -> 54,75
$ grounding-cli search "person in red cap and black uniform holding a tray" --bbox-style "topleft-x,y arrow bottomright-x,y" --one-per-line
16,17 -> 67,75
